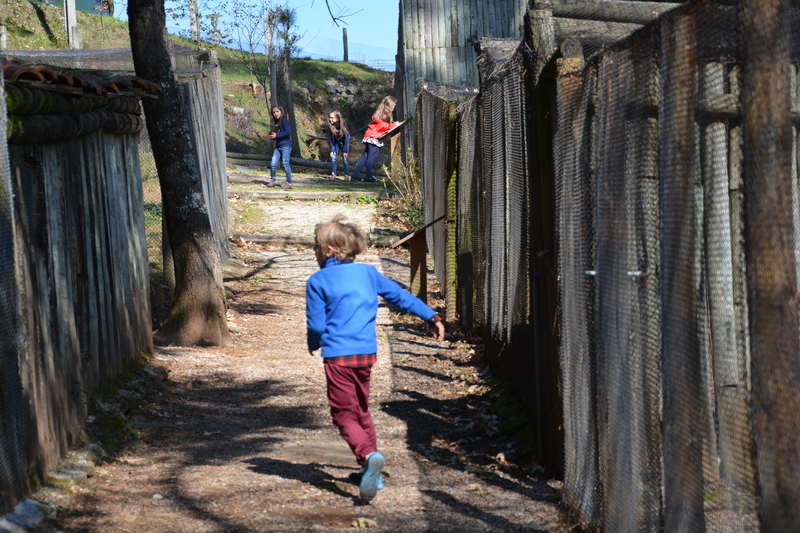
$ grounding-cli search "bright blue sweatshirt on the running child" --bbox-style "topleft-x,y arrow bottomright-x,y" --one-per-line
306,257 -> 436,357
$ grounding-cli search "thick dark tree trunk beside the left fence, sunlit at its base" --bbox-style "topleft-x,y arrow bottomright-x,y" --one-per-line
128,0 -> 230,346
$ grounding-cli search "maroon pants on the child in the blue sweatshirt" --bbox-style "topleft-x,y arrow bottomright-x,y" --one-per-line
324,364 -> 378,465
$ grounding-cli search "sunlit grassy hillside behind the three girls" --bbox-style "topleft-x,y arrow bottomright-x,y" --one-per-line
0,0 -> 394,161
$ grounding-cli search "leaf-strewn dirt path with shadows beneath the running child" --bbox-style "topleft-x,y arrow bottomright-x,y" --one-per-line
34,202 -> 567,533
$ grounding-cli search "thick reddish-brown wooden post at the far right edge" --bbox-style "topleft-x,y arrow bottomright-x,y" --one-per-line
738,0 -> 800,533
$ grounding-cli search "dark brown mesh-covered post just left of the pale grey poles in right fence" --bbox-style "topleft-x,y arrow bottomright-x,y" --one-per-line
659,14 -> 705,531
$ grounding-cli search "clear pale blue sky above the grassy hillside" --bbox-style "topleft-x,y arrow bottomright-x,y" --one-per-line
110,0 -> 400,70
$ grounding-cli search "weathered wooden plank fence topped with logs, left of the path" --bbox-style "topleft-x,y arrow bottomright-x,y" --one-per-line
0,61 -> 153,512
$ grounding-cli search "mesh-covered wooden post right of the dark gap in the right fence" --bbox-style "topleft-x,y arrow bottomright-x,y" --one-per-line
556,52 -> 602,529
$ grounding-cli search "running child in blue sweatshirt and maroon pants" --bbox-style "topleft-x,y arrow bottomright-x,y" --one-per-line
306,217 -> 445,500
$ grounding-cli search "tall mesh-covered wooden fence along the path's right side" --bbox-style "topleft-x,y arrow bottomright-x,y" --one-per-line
418,0 -> 800,532
